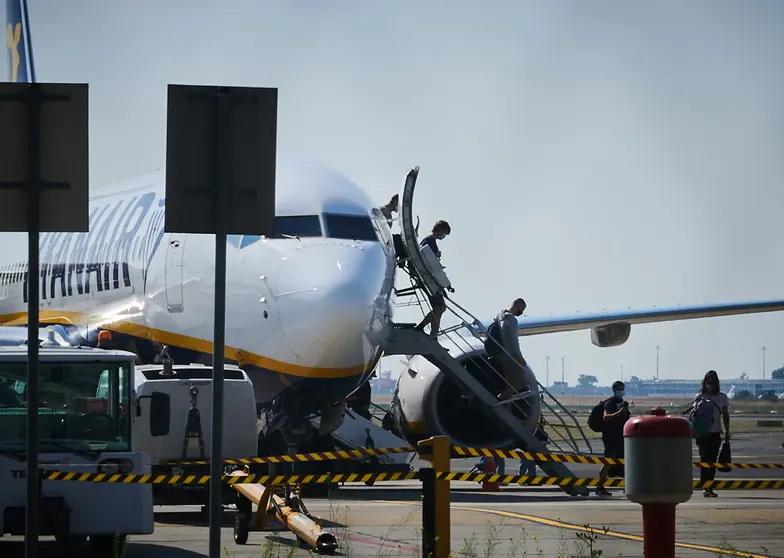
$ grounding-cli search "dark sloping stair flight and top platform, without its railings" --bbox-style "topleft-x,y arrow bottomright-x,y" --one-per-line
385,324 -> 588,496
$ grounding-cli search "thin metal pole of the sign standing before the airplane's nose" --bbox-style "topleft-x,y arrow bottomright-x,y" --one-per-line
209,90 -> 231,558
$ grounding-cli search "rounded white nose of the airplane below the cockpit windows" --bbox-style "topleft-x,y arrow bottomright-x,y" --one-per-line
276,244 -> 383,376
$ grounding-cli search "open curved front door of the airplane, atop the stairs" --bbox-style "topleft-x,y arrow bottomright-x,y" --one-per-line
400,167 -> 451,294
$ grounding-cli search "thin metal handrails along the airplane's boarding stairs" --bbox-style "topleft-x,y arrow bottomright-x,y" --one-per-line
396,259 -> 593,453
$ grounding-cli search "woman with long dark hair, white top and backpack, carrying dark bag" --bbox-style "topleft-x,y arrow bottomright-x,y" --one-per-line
689,370 -> 730,498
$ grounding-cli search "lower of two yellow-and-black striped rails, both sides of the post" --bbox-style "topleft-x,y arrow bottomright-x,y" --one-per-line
41,470 -> 784,490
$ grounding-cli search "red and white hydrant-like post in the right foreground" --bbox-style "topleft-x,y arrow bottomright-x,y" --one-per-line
623,407 -> 694,558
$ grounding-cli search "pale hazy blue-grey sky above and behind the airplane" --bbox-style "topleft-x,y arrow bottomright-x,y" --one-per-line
3,0 -> 784,383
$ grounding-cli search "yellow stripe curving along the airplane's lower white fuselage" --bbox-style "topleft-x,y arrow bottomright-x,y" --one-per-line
0,310 -> 370,380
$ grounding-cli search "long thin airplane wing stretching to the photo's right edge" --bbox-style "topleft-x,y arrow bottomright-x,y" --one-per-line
517,300 -> 784,335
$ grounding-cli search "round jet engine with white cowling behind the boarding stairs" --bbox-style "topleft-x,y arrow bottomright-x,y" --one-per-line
391,340 -> 541,449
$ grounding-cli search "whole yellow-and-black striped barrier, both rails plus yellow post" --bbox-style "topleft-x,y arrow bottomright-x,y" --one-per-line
40,436 -> 784,558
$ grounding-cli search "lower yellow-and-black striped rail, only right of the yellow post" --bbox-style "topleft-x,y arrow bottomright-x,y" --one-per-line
436,473 -> 784,490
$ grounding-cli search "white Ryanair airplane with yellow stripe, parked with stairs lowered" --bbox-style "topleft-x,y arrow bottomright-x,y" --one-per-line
0,0 -> 784,464
